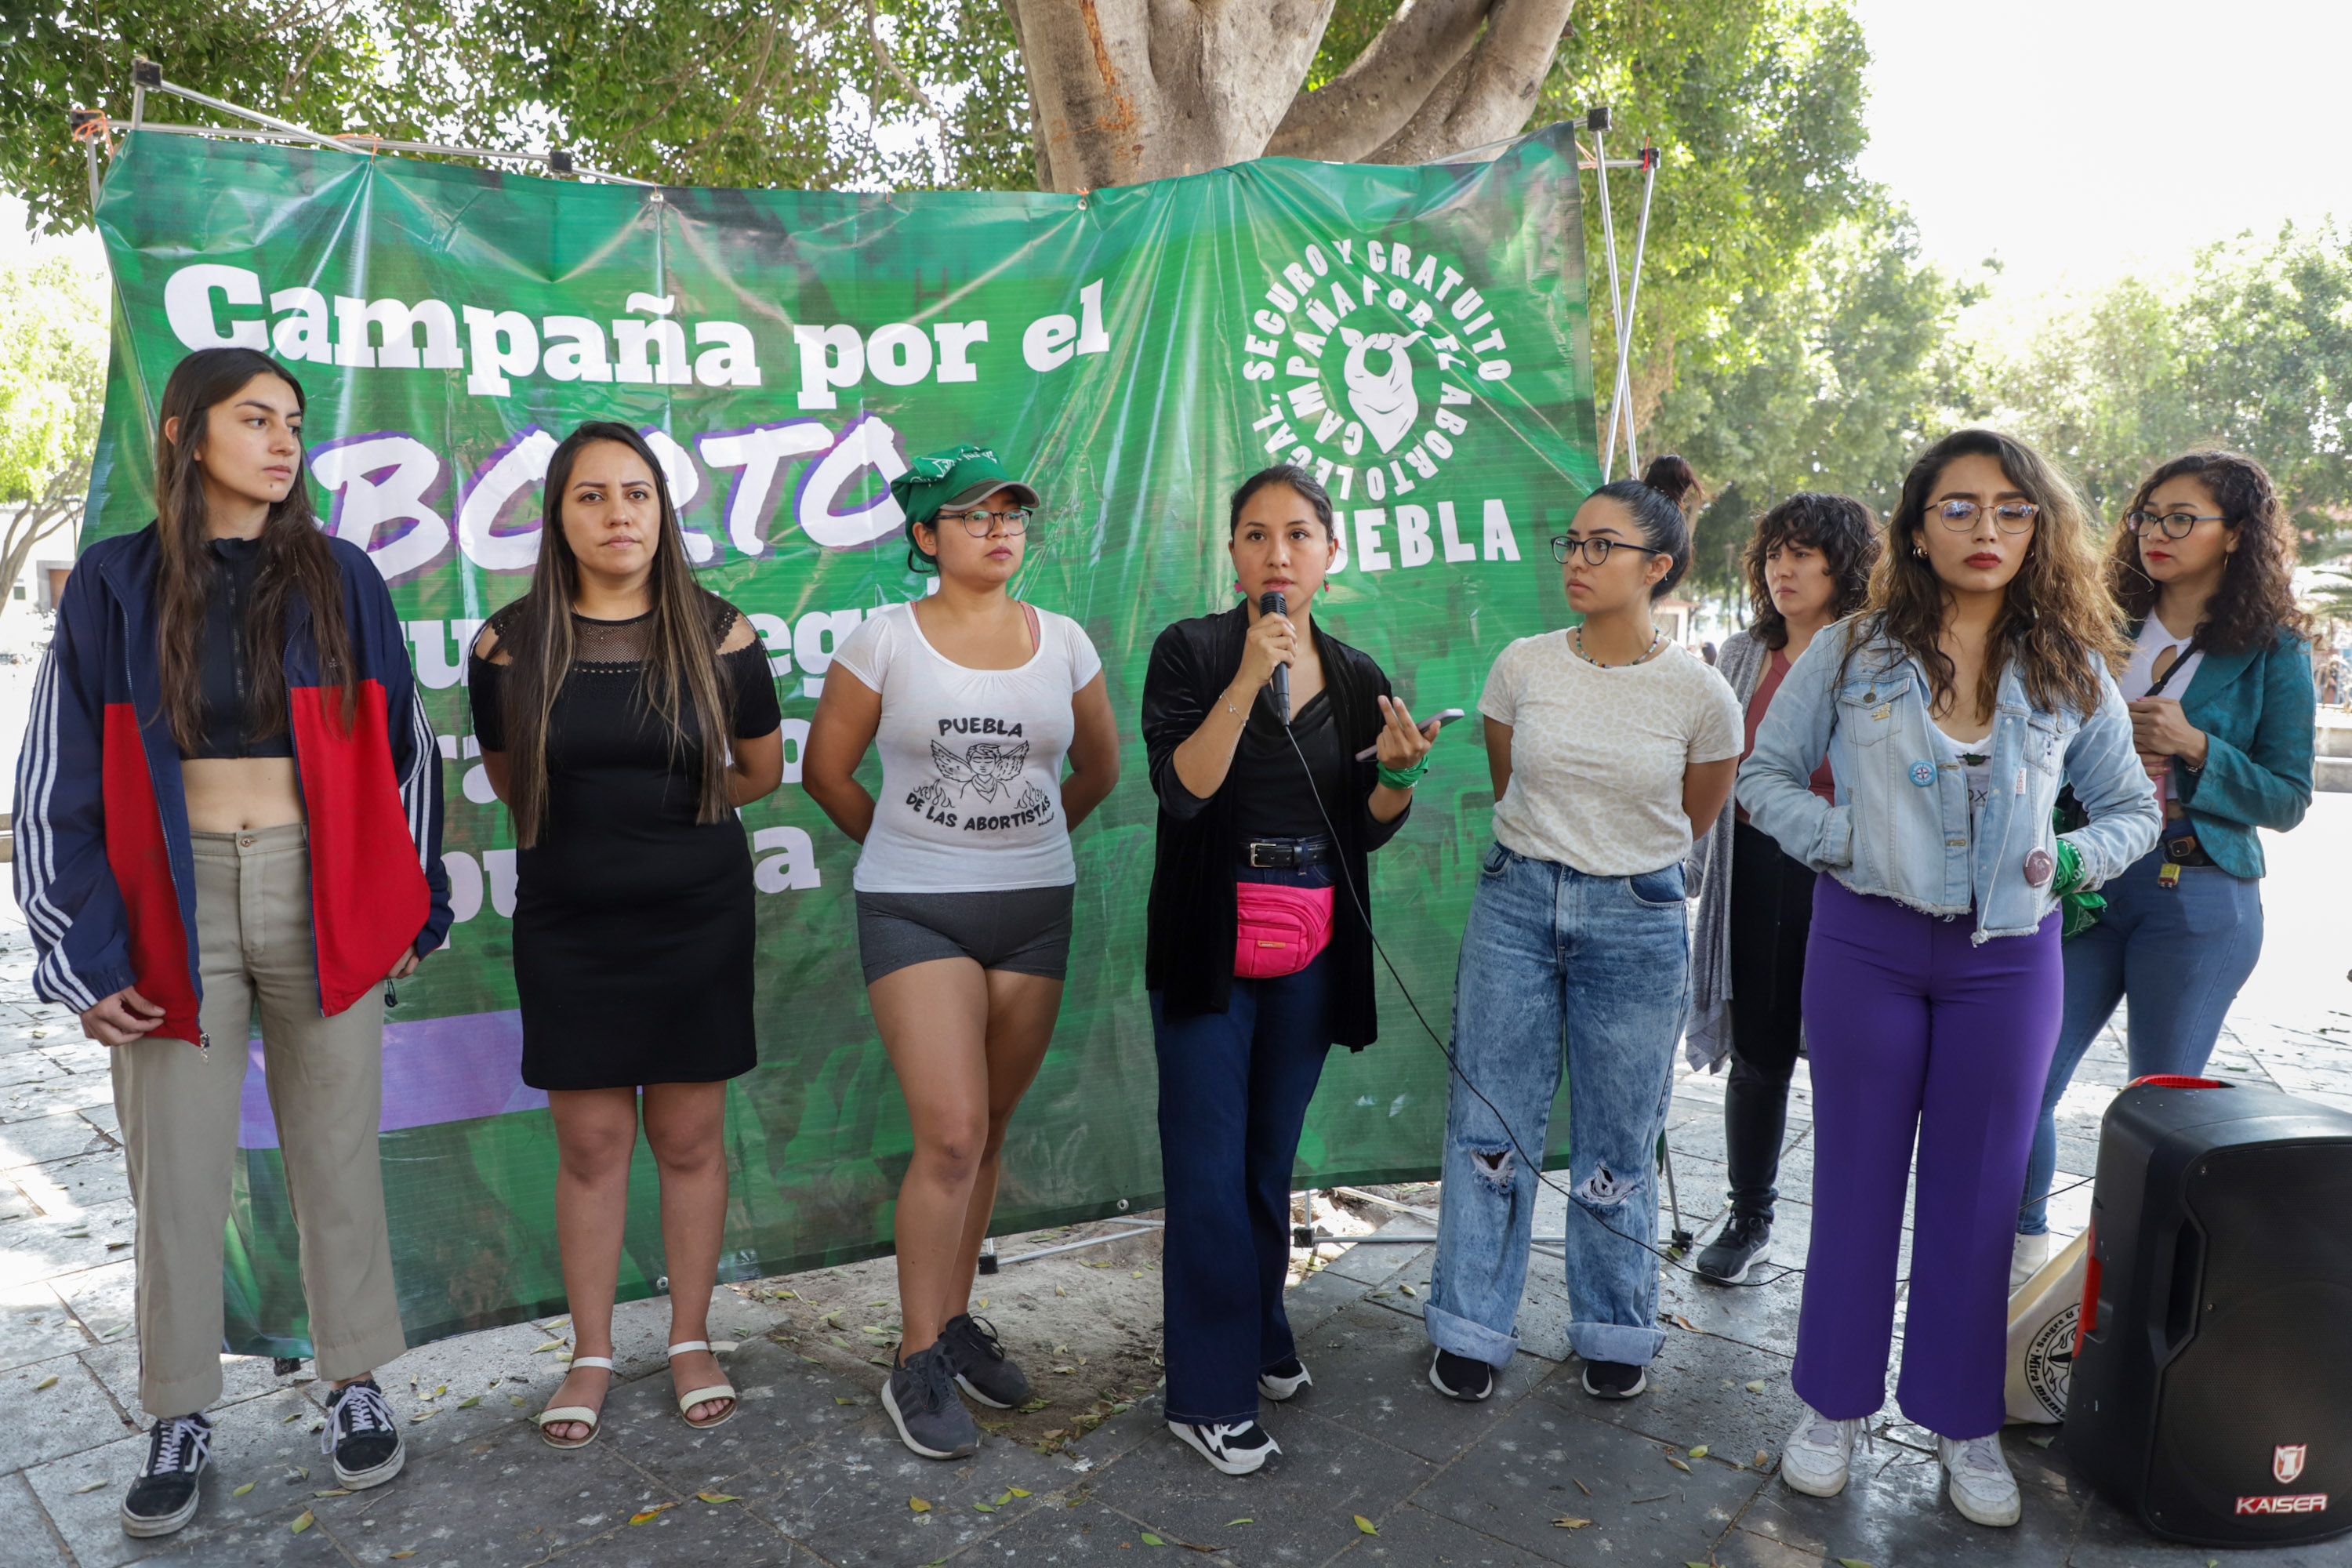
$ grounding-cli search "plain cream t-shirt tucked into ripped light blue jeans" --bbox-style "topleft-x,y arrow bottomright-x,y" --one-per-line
1477,633 -> 1745,877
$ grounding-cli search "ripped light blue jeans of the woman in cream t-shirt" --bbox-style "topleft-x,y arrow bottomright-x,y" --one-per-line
1428,844 -> 1691,1366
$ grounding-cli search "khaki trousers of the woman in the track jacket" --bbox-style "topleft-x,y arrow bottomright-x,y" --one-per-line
113,822 -> 407,1417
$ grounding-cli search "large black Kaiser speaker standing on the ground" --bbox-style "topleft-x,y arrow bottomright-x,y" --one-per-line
2065,1079 -> 2352,1547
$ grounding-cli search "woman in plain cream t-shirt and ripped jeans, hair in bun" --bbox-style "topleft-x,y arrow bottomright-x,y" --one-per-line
1425,456 -> 1740,1399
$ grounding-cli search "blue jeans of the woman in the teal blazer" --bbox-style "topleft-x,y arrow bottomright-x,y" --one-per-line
2018,848 -> 2263,1236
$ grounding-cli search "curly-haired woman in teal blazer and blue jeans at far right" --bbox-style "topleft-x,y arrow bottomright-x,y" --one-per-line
2009,452 -> 2319,1290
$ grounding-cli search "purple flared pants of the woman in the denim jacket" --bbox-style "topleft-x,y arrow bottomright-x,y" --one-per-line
1795,877 -> 2065,1439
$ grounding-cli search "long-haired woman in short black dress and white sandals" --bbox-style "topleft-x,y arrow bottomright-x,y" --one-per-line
470,423 -> 783,1448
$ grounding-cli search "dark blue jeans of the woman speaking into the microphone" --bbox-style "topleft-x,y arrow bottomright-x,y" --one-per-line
1152,867 -> 1334,1427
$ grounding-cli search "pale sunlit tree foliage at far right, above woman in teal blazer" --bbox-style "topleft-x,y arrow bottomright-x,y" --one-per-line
1983,221 -> 2352,560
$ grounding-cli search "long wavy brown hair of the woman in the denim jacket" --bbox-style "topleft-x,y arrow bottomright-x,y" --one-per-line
1846,430 -> 2129,715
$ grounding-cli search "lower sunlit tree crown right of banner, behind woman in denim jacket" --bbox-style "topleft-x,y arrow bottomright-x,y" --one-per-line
1644,209 -> 1980,600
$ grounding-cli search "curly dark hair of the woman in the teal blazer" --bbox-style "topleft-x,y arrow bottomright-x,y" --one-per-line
2107,452 -> 2312,654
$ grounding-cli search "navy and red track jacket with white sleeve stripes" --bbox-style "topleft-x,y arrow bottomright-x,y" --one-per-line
14,524 -> 449,1044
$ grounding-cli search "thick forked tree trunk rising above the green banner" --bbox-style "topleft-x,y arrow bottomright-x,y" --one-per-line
1004,0 -> 1573,191
